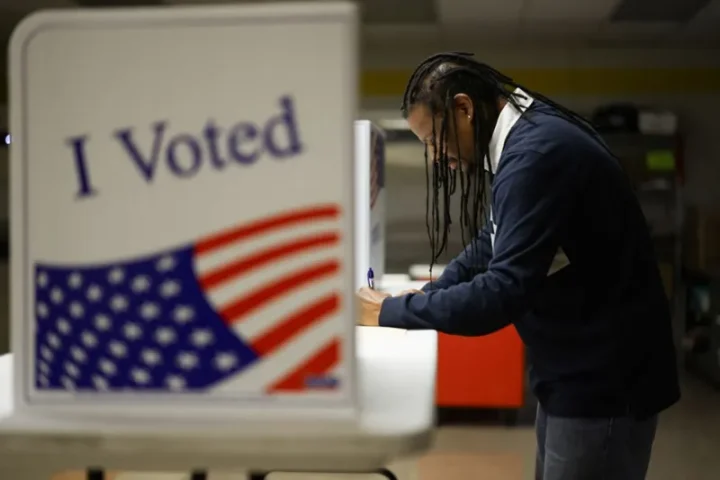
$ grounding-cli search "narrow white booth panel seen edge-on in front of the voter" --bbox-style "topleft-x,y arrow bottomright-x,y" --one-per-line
355,120 -> 386,288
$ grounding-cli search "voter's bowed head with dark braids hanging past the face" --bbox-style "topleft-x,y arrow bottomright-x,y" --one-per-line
401,53 -> 517,270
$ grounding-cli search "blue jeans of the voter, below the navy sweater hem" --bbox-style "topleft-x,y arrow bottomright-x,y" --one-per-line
535,406 -> 657,480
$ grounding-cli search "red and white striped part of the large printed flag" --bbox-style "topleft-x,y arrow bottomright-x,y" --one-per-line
195,205 -> 342,393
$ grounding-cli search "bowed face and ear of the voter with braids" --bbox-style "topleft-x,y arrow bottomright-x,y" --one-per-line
407,94 -> 475,169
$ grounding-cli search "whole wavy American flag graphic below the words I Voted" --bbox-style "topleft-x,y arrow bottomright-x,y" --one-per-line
35,205 -> 342,395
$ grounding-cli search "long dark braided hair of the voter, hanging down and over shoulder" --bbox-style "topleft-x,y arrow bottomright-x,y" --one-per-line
401,52 -> 607,273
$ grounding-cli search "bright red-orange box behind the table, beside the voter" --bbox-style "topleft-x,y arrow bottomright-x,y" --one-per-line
436,326 -> 525,408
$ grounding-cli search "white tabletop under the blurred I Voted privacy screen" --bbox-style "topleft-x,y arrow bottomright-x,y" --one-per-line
0,327 -> 437,472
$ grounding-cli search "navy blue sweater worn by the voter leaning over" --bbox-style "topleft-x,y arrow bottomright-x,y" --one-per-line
380,101 -> 680,418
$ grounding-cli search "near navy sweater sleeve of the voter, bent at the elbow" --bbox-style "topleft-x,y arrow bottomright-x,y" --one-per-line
380,151 -> 582,336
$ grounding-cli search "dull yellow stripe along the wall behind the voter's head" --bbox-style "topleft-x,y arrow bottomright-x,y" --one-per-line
360,68 -> 720,97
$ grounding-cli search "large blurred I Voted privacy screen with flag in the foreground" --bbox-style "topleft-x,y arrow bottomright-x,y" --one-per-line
11,4 -> 356,411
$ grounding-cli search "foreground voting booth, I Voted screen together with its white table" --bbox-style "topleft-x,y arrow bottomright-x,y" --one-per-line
0,2 -> 436,478
